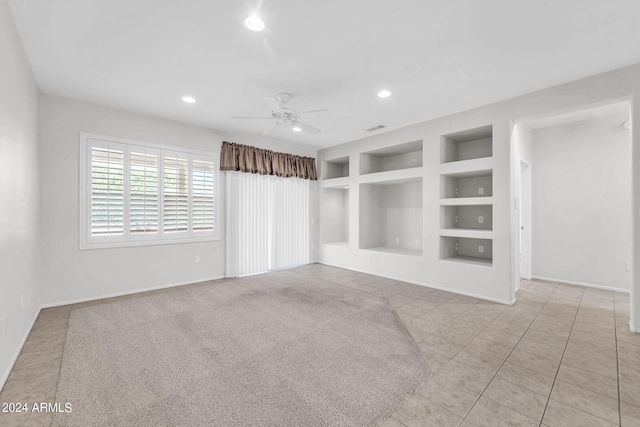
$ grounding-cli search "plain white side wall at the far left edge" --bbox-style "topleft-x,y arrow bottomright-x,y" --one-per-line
0,0 -> 40,389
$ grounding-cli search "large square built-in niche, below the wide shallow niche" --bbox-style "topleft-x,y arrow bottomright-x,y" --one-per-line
359,179 -> 423,256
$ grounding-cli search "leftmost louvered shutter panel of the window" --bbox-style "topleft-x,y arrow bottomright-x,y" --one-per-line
90,141 -> 124,237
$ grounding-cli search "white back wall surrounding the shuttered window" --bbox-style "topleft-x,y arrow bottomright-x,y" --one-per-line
40,94 -> 317,304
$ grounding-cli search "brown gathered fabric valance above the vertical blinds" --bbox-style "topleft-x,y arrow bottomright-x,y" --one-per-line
220,141 -> 318,181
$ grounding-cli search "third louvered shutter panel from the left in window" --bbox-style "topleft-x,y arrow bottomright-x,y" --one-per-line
162,153 -> 189,234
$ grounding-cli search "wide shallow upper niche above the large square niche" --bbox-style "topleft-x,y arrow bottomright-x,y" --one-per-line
360,140 -> 422,175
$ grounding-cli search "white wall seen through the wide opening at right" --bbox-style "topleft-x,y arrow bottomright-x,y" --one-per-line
532,114 -> 632,290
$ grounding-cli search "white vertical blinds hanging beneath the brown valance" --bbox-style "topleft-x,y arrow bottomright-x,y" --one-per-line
226,172 -> 309,277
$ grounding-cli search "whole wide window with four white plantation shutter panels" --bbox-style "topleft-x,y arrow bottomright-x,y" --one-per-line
80,133 -> 219,249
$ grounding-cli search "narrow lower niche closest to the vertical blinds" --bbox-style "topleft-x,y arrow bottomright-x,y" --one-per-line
322,188 -> 349,246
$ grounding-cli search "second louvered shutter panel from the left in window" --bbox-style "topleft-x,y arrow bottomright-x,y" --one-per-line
129,147 -> 160,240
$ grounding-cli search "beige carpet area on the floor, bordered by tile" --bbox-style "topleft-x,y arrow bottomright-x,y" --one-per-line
52,270 -> 431,427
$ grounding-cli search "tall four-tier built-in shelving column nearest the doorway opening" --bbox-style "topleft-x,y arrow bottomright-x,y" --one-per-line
440,125 -> 493,266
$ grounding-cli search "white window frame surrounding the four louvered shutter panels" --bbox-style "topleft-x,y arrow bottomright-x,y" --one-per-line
78,132 -> 220,250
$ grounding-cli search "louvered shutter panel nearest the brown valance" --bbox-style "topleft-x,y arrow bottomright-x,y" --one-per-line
191,156 -> 215,232
